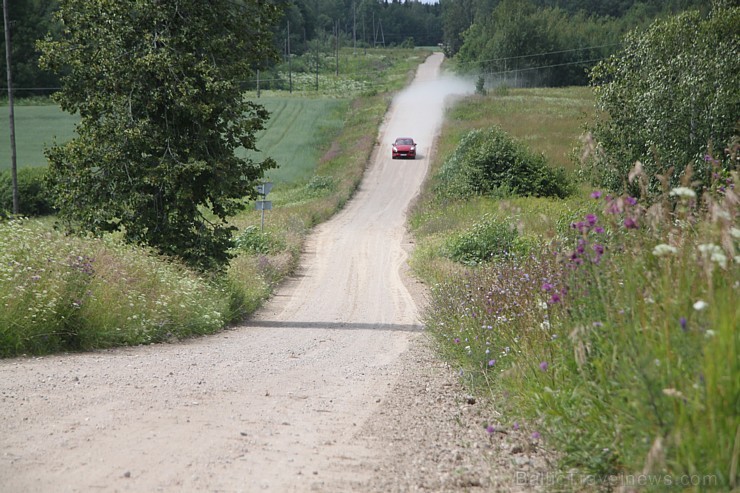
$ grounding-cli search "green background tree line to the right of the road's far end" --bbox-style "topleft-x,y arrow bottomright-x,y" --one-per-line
441,0 -> 709,87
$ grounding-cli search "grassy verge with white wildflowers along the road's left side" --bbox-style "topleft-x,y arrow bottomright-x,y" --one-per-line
0,50 -> 428,357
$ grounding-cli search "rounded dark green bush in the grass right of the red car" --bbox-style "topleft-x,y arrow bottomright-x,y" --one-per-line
435,126 -> 571,198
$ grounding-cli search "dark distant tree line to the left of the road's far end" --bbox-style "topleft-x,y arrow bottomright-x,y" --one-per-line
0,0 -> 442,97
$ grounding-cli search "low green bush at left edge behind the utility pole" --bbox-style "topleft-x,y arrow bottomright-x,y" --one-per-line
0,168 -> 54,216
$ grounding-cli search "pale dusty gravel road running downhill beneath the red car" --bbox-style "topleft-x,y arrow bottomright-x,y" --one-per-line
0,54 -> 548,492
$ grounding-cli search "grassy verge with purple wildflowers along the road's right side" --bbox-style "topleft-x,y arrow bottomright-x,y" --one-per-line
411,89 -> 740,491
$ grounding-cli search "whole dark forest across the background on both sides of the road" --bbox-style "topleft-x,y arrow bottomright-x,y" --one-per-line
0,0 -> 712,98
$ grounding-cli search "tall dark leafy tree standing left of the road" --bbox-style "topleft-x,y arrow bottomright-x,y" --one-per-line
40,0 -> 278,270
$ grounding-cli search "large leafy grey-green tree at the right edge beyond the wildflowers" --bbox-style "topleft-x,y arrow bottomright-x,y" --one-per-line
587,1 -> 740,198
